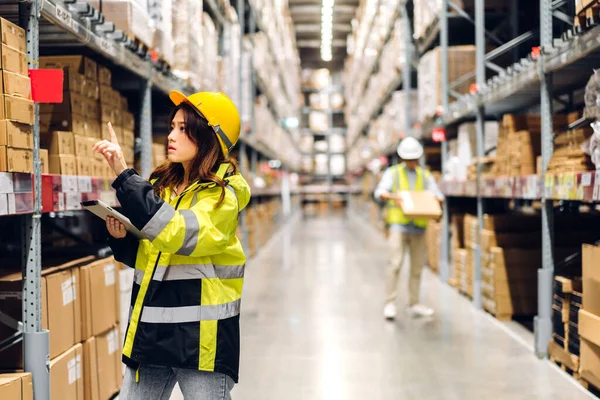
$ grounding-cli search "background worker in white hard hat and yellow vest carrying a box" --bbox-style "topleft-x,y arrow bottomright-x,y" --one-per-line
375,137 -> 444,320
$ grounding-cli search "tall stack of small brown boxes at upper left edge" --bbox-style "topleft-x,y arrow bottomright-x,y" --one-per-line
0,18 -> 34,172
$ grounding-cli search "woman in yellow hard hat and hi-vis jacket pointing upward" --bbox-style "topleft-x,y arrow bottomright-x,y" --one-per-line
94,91 -> 250,400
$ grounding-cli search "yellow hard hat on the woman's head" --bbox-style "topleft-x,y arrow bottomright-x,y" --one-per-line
169,90 -> 240,156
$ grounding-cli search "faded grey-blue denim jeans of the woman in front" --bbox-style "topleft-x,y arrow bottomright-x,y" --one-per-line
119,365 -> 234,400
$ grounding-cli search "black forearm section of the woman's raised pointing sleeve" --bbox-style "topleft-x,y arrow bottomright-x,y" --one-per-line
112,169 -> 165,230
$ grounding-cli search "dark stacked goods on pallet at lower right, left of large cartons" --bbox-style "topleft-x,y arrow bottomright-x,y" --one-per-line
549,276 -> 583,372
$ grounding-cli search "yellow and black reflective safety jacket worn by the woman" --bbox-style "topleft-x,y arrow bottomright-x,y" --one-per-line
106,164 -> 250,382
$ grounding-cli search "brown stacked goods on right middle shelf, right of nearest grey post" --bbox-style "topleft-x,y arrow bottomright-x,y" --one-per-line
547,111 -> 595,173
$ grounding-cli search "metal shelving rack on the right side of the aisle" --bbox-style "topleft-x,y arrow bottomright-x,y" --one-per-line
423,0 -> 600,357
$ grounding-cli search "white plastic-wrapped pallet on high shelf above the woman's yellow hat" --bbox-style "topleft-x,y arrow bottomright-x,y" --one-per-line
172,0 -> 205,89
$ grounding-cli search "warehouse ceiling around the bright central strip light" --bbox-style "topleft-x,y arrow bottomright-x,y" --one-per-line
289,0 -> 359,71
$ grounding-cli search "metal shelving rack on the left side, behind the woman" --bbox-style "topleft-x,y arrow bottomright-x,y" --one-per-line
0,0 -> 302,400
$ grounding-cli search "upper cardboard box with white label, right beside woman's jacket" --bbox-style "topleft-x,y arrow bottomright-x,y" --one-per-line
80,257 -> 118,339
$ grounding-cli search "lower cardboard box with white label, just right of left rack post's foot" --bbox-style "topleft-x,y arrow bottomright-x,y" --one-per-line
50,344 -> 84,400
